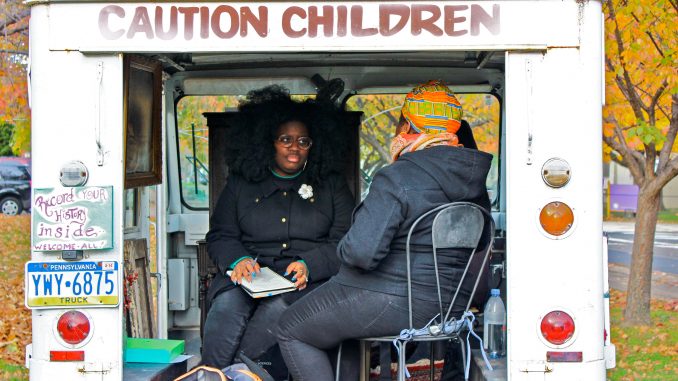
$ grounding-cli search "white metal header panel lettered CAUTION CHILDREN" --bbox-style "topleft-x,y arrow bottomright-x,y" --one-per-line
49,1 -> 578,52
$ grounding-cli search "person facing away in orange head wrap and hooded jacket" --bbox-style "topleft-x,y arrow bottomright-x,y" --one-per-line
278,81 -> 492,381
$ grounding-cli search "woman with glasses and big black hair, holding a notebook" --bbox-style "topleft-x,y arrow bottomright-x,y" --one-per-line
202,86 -> 354,369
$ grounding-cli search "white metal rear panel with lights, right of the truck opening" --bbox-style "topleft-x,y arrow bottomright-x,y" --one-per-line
506,2 -> 605,381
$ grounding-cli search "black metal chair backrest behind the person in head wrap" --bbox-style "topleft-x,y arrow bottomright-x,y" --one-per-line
406,201 -> 494,329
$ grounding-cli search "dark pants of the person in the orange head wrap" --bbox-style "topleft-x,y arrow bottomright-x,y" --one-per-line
278,280 -> 438,381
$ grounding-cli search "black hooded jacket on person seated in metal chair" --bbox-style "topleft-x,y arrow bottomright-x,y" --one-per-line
333,146 -> 492,310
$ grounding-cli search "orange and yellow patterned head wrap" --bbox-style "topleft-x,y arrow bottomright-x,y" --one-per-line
401,80 -> 462,134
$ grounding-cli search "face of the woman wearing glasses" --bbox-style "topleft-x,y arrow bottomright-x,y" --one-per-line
273,121 -> 311,176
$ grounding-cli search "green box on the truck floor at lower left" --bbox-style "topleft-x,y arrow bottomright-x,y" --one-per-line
125,337 -> 184,364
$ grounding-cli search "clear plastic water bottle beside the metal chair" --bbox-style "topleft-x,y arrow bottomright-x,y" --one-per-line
483,288 -> 506,359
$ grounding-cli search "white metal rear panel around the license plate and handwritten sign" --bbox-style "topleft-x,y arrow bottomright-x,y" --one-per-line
29,5 -> 123,380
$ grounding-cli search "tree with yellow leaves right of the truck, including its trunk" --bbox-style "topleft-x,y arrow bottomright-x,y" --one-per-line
603,0 -> 678,325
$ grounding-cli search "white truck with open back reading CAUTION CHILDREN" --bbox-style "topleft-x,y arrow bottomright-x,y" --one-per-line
26,0 -> 614,381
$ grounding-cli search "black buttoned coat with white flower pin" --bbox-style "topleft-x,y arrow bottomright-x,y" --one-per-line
207,173 -> 354,302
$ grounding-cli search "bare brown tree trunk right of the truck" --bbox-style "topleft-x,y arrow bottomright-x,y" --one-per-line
624,187 -> 659,325
